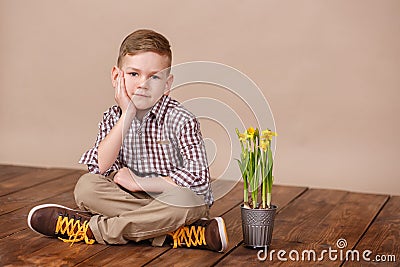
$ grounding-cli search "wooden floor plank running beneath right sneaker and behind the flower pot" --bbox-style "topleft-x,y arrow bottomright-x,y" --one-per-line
141,186 -> 307,266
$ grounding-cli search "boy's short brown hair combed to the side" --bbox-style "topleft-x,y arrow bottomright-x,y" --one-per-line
117,29 -> 172,67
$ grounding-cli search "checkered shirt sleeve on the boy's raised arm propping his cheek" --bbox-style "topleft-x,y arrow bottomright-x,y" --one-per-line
79,106 -> 122,176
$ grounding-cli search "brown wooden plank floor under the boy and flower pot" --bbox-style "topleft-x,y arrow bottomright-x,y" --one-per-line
0,165 -> 400,266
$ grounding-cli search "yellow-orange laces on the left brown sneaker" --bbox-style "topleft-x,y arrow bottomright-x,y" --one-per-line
56,216 -> 95,246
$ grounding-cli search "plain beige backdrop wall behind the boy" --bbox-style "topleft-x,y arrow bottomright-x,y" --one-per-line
0,0 -> 400,194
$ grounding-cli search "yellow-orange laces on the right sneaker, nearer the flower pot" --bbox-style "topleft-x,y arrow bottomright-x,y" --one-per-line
169,225 -> 207,248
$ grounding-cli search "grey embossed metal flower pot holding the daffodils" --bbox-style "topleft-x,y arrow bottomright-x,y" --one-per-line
241,205 -> 277,248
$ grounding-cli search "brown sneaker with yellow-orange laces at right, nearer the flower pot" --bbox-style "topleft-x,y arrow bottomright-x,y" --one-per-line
169,217 -> 228,252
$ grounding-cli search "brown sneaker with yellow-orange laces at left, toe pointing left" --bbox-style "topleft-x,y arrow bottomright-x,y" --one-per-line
28,204 -> 95,245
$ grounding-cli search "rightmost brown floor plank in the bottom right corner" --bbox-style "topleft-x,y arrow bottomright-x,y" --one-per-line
344,196 -> 400,267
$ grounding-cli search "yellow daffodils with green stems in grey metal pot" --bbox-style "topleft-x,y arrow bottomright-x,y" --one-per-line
236,127 -> 277,248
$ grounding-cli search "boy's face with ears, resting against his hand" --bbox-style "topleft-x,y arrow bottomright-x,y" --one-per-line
112,52 -> 173,114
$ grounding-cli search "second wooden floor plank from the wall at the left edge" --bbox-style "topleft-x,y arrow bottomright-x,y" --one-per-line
0,168 -> 76,196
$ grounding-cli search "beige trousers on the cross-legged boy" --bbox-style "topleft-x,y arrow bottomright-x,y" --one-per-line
74,173 -> 209,246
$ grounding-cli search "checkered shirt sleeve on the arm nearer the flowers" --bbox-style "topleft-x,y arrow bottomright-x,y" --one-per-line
170,118 -> 211,195
